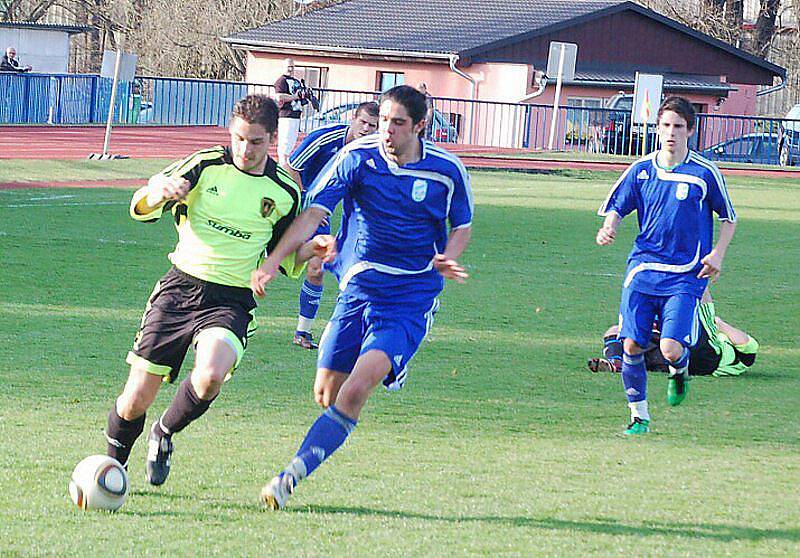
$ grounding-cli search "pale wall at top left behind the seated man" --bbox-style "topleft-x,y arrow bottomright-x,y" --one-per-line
0,27 -> 69,73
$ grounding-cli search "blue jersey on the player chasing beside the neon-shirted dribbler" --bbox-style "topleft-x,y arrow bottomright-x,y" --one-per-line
308,135 -> 473,301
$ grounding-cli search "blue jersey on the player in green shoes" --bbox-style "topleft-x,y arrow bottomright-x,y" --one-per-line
598,151 -> 736,297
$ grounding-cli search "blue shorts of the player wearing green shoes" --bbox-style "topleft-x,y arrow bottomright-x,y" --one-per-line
619,289 -> 700,347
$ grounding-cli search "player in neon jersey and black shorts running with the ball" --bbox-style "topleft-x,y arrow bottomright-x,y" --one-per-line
106,95 -> 334,485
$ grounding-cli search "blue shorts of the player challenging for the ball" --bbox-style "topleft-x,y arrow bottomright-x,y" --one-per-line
317,293 -> 439,390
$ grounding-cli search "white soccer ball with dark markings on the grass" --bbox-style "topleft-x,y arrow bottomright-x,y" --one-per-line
69,455 -> 128,511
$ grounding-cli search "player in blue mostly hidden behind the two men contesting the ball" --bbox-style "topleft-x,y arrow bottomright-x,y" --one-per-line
289,101 -> 378,349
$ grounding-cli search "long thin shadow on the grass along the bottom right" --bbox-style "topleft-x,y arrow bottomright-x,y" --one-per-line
288,504 -> 800,542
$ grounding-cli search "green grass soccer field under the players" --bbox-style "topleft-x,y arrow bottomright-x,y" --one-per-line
0,161 -> 800,557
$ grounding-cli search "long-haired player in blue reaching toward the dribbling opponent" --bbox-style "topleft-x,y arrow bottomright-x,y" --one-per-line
251,85 -> 473,509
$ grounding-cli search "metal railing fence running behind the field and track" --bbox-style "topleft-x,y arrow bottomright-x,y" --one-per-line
0,74 -> 800,164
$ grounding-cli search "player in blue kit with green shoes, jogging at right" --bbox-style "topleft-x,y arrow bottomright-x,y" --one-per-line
596,97 -> 736,434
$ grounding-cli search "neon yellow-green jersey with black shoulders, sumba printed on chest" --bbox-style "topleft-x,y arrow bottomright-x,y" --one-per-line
130,146 -> 303,288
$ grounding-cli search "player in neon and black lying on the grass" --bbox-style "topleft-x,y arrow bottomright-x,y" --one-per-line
587,289 -> 758,377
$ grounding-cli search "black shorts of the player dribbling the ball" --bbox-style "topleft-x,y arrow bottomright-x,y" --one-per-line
127,266 -> 256,382
